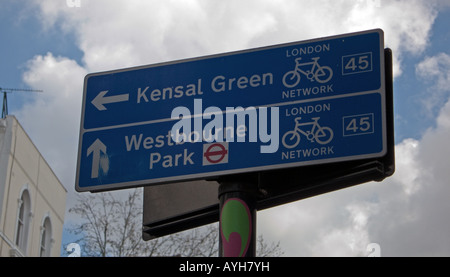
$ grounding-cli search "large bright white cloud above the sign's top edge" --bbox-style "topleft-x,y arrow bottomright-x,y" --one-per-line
29,0 -> 436,75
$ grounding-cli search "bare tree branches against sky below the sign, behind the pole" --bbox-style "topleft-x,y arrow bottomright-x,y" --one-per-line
69,189 -> 283,257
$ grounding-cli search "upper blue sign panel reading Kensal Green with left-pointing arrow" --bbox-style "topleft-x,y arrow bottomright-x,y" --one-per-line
82,30 -> 384,130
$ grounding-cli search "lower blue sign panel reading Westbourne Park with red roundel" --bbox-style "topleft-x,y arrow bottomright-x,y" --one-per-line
77,92 -> 386,191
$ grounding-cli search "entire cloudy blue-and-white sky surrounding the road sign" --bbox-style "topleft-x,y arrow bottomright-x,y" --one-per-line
0,0 -> 450,256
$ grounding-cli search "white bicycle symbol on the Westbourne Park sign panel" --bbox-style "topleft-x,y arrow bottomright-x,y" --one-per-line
281,117 -> 333,149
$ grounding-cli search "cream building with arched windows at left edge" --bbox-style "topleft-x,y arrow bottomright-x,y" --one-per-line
0,116 -> 67,257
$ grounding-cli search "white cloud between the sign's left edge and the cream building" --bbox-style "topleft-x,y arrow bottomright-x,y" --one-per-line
17,53 -> 86,187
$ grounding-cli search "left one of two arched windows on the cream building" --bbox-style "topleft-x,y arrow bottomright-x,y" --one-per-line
16,189 -> 31,254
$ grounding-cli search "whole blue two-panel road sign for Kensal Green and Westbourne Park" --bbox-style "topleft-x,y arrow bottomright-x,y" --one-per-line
76,29 -> 387,191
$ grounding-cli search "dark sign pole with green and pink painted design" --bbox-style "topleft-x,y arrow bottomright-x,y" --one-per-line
219,177 -> 257,257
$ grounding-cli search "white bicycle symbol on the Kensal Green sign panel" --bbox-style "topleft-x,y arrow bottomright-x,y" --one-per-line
283,57 -> 333,88
